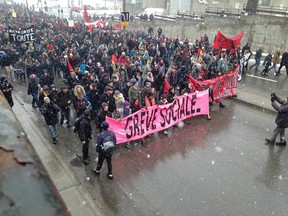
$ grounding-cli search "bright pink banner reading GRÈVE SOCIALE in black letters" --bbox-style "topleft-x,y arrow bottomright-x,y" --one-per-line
106,90 -> 209,144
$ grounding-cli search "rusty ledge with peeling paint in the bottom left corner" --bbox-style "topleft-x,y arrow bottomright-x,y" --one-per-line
0,91 -> 70,216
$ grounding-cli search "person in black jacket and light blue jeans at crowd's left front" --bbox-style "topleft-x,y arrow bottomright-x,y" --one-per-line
40,97 -> 60,144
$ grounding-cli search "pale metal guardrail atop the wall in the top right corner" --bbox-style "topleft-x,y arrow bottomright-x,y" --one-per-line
243,4 -> 288,17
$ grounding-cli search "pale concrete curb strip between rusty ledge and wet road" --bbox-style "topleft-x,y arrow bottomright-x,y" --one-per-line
13,94 -> 104,216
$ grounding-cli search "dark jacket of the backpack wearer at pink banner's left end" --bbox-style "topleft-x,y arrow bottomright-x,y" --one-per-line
96,130 -> 117,156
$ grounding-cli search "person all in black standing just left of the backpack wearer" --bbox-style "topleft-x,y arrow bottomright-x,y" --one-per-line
77,109 -> 92,164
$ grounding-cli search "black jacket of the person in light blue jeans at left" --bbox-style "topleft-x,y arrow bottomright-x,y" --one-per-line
40,102 -> 60,125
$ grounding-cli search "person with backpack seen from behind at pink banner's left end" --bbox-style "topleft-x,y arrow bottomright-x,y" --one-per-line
92,121 -> 116,180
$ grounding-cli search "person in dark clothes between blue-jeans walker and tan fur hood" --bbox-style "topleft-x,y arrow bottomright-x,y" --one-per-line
57,86 -> 73,128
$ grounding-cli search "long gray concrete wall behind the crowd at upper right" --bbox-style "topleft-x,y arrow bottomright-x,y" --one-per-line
130,15 -> 288,52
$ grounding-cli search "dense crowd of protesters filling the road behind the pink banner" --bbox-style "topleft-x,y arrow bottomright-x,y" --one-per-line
0,2 -> 287,155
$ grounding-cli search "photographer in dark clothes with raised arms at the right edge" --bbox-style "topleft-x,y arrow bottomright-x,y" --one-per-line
265,93 -> 288,146
